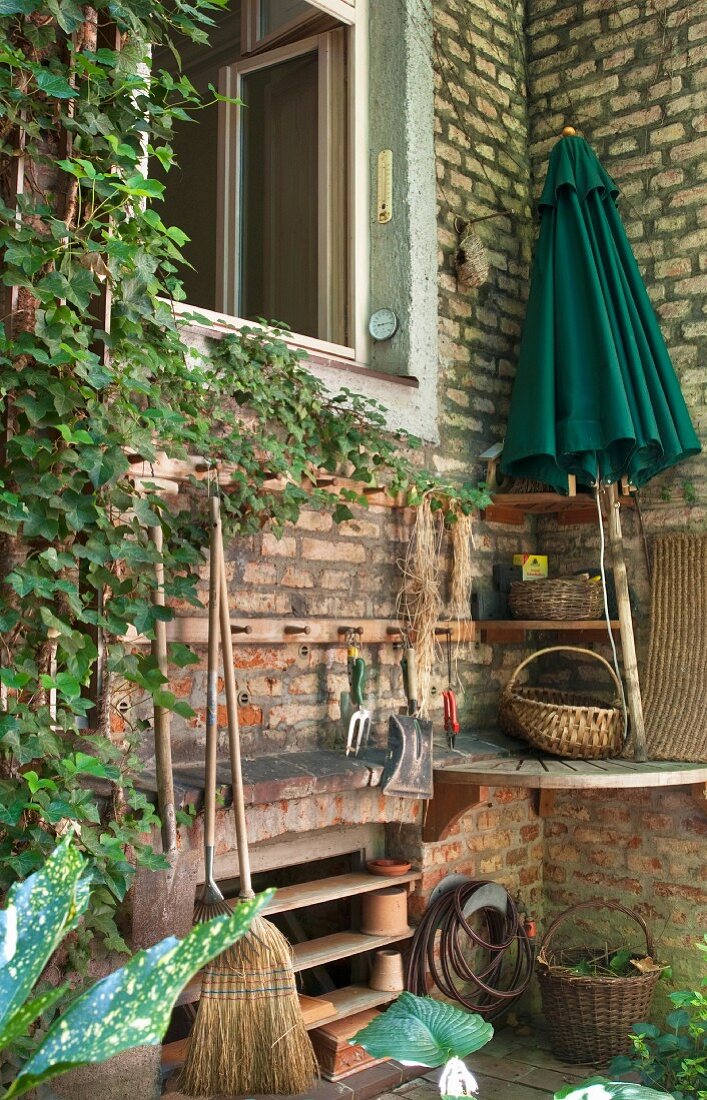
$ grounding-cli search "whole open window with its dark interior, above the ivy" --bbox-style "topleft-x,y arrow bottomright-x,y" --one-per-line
156,0 -> 366,358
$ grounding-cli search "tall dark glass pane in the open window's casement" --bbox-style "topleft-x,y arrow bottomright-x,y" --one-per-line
239,53 -> 319,337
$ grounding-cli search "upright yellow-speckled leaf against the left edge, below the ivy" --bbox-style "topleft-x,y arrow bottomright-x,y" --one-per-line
0,838 -> 89,1031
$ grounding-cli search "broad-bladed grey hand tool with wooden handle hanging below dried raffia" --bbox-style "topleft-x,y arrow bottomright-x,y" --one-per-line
380,646 -> 432,799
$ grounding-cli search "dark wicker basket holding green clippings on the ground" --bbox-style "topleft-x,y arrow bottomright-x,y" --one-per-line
535,902 -> 661,1063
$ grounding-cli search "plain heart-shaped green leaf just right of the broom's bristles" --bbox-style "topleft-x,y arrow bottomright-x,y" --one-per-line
350,993 -> 494,1066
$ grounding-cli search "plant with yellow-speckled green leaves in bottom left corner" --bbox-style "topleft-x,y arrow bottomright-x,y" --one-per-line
0,839 -> 268,1100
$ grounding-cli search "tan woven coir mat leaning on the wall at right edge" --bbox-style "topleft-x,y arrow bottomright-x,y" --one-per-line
643,535 -> 707,763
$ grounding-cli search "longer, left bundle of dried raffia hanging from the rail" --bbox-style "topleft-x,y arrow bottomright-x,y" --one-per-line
397,496 -> 444,716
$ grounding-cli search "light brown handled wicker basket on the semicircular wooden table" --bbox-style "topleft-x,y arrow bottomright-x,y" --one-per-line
498,646 -> 625,760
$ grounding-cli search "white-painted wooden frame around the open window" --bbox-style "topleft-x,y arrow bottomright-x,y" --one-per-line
194,0 -> 369,365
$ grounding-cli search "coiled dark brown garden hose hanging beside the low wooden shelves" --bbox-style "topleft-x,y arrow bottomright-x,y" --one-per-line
406,881 -> 533,1020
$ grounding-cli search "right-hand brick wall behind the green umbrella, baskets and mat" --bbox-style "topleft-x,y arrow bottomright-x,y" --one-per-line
528,0 -> 707,1011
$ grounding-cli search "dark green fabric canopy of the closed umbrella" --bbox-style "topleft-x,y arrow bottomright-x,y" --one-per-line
501,135 -> 700,492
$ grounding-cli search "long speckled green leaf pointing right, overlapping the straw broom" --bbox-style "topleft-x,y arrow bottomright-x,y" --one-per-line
5,890 -> 273,1100
